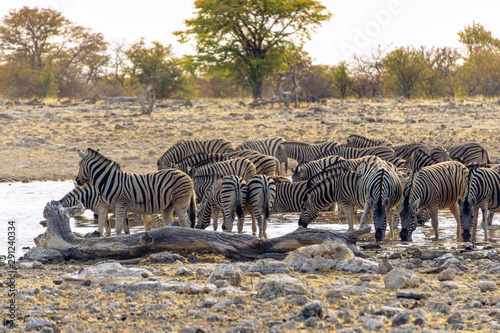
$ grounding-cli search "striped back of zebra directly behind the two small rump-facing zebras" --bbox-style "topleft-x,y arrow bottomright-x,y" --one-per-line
188,158 -> 256,181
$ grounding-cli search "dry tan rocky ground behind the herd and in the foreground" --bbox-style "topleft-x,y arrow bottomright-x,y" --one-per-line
0,95 -> 500,332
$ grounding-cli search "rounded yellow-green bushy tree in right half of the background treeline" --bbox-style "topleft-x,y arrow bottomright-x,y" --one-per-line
383,47 -> 426,99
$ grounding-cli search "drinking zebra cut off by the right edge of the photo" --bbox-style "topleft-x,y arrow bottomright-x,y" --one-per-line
458,164 -> 500,242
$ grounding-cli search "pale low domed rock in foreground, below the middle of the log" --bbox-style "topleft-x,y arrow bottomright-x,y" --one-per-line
256,275 -> 308,299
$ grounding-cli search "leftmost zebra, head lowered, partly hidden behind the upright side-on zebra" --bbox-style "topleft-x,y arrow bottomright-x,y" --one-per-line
59,183 -> 112,237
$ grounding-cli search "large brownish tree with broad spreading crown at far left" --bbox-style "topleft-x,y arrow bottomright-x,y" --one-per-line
0,7 -> 107,97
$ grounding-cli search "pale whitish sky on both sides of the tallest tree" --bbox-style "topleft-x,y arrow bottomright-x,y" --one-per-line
0,0 -> 500,65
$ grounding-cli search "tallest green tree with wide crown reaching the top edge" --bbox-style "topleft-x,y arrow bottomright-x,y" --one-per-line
175,0 -> 332,98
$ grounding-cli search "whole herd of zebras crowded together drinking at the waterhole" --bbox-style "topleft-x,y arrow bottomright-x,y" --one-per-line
55,135 -> 500,241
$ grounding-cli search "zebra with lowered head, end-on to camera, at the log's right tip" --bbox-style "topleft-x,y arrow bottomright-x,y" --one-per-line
356,160 -> 403,242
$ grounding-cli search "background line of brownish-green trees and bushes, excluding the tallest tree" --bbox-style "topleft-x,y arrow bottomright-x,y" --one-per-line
0,7 -> 500,99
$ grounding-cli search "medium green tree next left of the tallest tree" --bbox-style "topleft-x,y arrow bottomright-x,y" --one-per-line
125,39 -> 186,98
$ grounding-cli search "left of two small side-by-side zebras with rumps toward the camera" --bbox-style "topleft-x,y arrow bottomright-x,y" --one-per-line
196,176 -> 247,232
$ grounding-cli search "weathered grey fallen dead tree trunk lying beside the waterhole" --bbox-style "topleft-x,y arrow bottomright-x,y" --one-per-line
35,201 -> 370,260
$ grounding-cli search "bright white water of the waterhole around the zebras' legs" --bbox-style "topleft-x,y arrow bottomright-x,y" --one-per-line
0,181 -> 500,258
